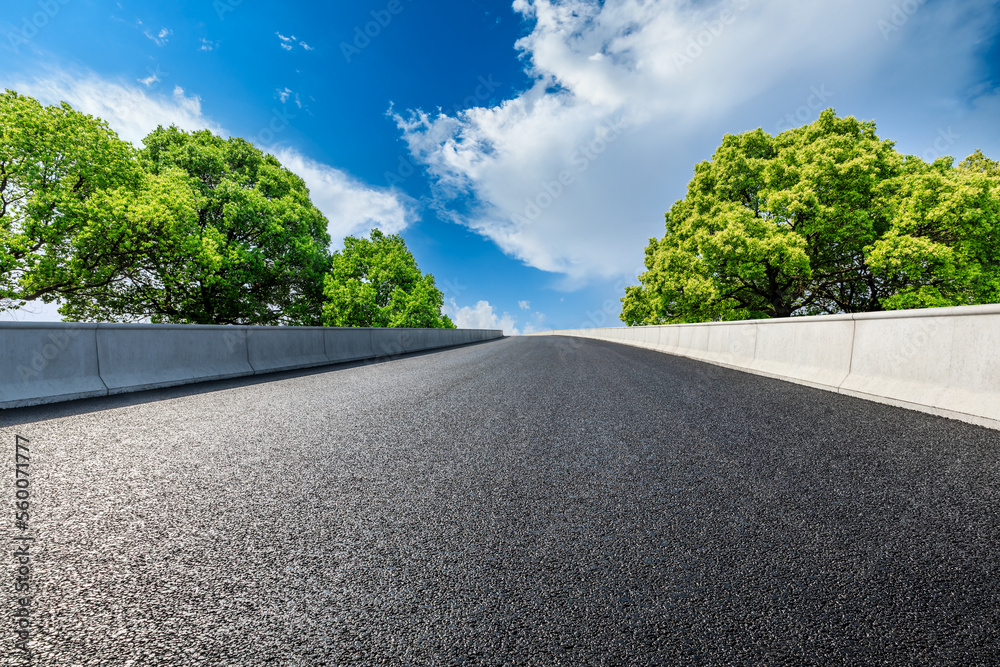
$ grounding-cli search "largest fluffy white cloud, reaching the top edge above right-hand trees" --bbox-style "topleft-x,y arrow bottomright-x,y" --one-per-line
395,0 -> 997,284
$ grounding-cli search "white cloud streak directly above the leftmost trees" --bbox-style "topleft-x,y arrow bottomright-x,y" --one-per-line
4,71 -> 225,145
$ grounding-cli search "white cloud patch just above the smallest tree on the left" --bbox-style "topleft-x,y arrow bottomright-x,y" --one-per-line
271,148 -> 415,247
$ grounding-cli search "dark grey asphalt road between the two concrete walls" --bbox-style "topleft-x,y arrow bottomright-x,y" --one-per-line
0,338 -> 1000,666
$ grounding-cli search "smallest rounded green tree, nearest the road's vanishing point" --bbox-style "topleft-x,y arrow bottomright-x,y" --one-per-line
323,229 -> 455,329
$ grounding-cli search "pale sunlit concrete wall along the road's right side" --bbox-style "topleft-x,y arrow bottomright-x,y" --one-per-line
532,305 -> 1000,429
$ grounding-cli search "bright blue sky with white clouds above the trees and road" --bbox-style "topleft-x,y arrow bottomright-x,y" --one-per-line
0,0 -> 1000,333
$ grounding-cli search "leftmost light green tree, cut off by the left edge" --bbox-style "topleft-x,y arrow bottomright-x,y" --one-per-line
0,90 -> 142,309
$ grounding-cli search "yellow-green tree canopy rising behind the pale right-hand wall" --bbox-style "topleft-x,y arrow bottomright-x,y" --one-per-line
621,109 -> 1000,325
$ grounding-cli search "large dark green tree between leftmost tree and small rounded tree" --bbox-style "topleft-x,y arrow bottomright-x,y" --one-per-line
60,127 -> 330,325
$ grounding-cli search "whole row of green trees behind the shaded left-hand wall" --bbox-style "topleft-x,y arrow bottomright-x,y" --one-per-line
0,90 -> 454,327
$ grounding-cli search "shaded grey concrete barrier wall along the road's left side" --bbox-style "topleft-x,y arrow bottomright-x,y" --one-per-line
0,322 -> 503,409
